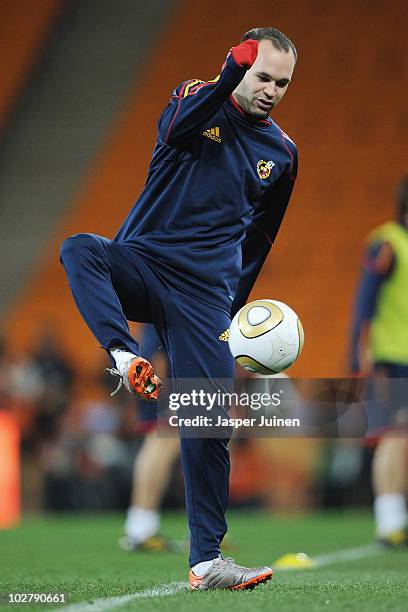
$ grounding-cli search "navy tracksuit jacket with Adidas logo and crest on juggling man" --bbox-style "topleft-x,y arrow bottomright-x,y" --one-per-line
115,55 -> 297,312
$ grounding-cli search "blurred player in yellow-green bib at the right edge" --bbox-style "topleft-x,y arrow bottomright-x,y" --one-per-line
351,176 -> 408,546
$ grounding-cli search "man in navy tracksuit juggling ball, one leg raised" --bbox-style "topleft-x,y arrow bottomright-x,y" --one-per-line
61,28 -> 297,589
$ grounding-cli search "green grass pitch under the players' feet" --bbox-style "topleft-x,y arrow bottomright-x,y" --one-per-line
0,512 -> 408,612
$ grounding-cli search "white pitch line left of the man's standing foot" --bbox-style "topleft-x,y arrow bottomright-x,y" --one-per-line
51,582 -> 188,612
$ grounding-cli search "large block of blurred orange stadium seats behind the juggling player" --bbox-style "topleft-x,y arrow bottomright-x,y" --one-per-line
3,0 -> 408,376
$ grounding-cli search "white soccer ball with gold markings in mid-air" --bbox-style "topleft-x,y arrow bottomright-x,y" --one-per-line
228,300 -> 304,375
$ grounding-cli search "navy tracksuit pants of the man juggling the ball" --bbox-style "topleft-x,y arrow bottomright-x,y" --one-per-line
61,234 -> 233,566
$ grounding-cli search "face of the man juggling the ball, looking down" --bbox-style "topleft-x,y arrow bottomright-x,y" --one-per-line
234,40 -> 295,119
